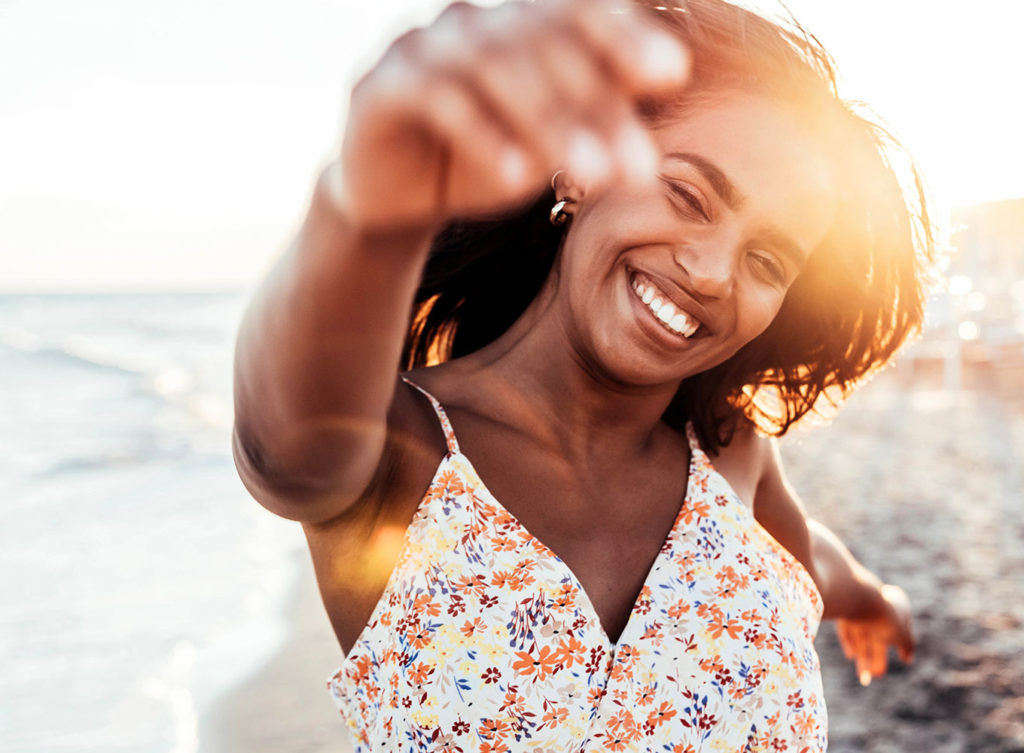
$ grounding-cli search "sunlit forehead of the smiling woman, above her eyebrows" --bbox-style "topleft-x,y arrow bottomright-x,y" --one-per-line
653,94 -> 838,251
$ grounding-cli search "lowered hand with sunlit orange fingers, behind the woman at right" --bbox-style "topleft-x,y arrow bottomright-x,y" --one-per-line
836,584 -> 914,685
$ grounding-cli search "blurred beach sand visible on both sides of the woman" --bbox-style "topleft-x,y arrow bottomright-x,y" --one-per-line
200,368 -> 1024,753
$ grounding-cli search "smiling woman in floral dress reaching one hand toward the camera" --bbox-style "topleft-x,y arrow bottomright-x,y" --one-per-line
234,0 -> 932,751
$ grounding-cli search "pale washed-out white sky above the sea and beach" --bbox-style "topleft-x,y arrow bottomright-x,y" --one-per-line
0,0 -> 1024,292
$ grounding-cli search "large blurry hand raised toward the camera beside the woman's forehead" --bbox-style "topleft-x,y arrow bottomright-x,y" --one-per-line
334,0 -> 689,228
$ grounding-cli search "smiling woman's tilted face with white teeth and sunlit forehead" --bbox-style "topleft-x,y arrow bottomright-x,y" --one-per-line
556,95 -> 837,385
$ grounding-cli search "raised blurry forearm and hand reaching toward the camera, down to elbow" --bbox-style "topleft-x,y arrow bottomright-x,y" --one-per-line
233,0 -> 689,524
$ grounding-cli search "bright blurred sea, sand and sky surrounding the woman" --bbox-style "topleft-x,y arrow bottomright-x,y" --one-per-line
0,0 -> 1024,753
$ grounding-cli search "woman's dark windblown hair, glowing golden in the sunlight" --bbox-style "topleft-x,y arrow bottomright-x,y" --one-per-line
403,0 -> 936,452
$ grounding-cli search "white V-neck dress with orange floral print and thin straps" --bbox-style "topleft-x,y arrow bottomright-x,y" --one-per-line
328,385 -> 826,753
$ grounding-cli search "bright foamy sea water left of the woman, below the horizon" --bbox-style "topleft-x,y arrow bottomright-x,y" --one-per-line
0,294 -> 302,753
